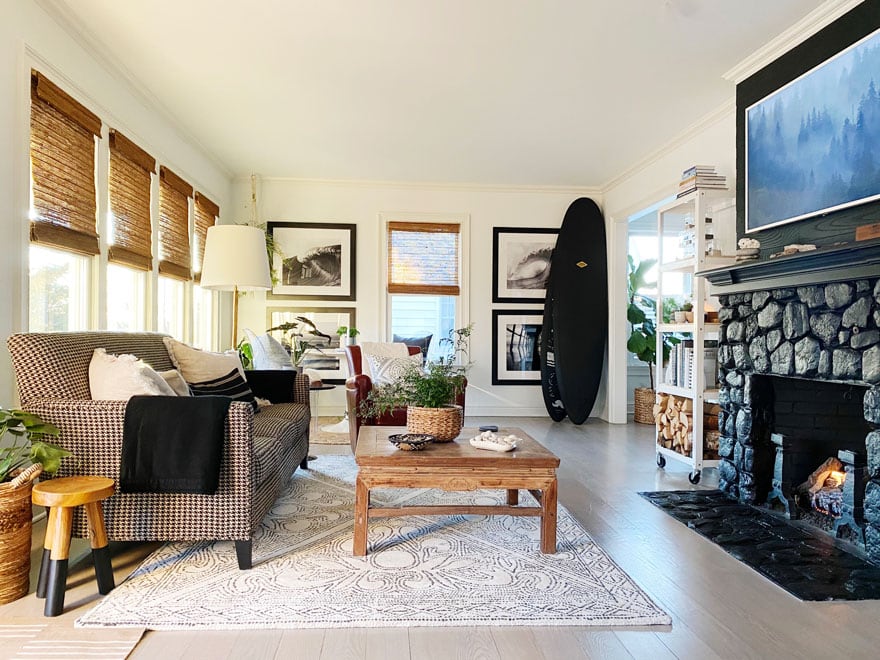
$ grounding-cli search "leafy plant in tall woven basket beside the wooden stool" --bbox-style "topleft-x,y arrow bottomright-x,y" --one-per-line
0,408 -> 70,604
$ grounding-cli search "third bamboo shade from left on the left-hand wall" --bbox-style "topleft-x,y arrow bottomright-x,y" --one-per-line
159,165 -> 193,280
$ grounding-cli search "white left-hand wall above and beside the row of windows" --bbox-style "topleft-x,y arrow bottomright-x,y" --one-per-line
0,0 -> 230,406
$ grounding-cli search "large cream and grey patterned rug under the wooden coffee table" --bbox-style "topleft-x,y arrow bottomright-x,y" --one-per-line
77,456 -> 671,630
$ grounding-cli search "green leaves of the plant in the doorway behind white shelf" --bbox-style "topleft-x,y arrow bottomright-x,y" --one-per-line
626,255 -> 680,390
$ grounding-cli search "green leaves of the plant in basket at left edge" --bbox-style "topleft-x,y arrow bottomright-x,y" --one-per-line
0,408 -> 70,482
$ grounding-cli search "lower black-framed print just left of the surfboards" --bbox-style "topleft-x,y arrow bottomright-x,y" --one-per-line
492,309 -> 544,385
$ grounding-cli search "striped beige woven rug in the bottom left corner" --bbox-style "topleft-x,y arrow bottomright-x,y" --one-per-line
0,620 -> 144,660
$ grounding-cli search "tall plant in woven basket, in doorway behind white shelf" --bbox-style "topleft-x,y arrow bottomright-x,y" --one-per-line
626,255 -> 679,424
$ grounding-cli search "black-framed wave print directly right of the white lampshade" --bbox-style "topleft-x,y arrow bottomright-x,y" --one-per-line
267,222 -> 357,301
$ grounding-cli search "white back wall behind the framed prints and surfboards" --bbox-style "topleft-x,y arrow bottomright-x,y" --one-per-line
233,178 -> 606,417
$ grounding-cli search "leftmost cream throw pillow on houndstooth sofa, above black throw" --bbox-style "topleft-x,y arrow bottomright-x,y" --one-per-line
89,348 -> 176,401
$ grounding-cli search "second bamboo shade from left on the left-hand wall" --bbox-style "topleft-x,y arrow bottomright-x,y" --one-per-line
107,130 -> 156,270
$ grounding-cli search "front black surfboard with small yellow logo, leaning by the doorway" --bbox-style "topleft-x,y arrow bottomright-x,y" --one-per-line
548,197 -> 608,424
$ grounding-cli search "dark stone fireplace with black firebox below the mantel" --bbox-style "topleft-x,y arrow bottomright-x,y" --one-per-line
710,276 -> 880,561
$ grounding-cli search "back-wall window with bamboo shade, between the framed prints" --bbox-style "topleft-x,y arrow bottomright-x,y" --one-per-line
387,222 -> 462,359
